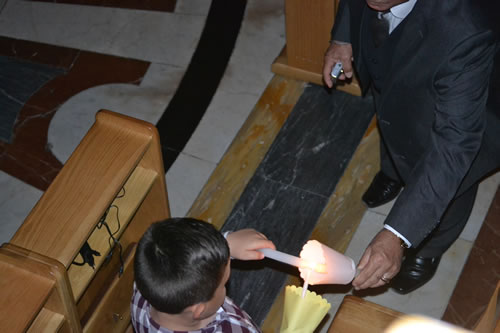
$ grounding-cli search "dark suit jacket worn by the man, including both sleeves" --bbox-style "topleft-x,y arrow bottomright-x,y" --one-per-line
332,0 -> 500,246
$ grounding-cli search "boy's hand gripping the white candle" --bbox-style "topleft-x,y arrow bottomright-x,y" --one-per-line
226,229 -> 276,260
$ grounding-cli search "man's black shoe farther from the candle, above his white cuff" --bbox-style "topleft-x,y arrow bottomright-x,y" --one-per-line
361,171 -> 403,208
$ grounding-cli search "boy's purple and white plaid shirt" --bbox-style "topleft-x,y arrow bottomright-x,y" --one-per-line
130,283 -> 261,333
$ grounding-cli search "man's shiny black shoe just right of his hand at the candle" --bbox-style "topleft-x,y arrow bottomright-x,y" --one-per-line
390,256 -> 441,295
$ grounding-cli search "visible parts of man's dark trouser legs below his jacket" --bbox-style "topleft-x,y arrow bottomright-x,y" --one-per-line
380,139 -> 478,258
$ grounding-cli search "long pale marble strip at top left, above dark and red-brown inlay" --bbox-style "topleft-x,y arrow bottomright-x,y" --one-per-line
0,1 -> 205,67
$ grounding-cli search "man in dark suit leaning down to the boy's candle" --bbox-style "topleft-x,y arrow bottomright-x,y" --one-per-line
323,0 -> 500,294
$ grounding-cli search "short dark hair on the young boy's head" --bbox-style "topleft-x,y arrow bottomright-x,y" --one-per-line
134,218 -> 229,314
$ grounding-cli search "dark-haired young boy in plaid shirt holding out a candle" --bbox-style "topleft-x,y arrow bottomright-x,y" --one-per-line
131,218 -> 275,333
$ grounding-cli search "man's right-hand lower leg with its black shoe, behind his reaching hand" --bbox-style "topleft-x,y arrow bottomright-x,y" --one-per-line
391,184 -> 478,294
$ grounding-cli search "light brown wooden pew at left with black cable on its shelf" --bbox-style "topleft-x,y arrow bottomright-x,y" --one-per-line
0,110 -> 170,333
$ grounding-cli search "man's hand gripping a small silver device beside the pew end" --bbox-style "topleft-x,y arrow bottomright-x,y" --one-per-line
323,42 -> 352,88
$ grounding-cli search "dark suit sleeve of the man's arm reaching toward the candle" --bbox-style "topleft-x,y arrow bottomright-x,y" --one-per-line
385,31 -> 495,247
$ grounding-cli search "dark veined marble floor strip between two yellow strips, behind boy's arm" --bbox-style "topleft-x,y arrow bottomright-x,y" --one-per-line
222,85 -> 374,325
